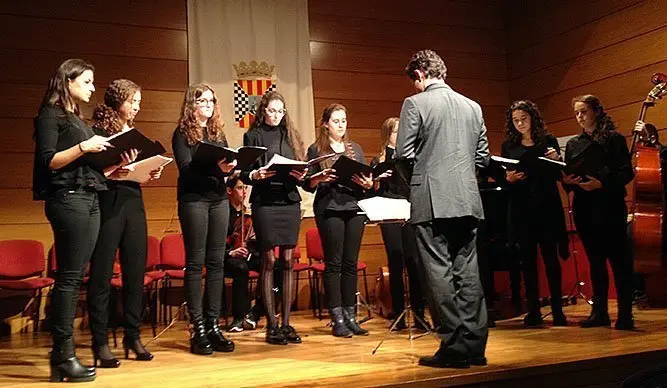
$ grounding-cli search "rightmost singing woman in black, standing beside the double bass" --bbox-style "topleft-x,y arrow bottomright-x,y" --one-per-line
563,94 -> 634,330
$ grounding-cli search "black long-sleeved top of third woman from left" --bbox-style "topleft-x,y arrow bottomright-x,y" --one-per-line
171,128 -> 229,202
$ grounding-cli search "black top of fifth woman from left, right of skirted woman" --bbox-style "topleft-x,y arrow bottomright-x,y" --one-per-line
304,142 -> 366,215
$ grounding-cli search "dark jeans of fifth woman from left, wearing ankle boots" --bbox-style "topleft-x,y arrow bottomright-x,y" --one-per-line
315,211 -> 366,309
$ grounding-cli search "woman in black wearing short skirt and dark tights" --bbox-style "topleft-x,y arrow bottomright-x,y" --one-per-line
241,92 -> 305,345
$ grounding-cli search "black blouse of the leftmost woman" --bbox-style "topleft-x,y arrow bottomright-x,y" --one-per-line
32,105 -> 107,200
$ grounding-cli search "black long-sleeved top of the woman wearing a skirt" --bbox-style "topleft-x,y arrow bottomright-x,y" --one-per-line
241,124 -> 301,205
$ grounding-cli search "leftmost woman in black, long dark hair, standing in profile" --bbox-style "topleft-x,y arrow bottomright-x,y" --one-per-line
32,59 -> 109,382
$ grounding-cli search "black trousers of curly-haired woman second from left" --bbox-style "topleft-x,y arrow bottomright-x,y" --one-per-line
88,186 -> 148,346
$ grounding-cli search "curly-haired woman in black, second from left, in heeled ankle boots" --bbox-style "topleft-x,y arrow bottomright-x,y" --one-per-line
88,79 -> 162,368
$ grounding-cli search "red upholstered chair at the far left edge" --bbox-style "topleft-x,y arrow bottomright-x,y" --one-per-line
0,240 -> 54,332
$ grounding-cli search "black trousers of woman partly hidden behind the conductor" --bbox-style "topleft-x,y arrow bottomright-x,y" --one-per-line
380,224 -> 424,314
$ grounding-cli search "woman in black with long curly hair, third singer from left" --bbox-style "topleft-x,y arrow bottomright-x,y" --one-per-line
172,84 -> 236,355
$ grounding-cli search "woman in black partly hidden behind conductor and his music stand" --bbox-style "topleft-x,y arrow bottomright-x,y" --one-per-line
371,117 -> 426,329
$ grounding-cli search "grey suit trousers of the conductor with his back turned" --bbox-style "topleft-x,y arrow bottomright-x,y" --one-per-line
414,217 -> 488,357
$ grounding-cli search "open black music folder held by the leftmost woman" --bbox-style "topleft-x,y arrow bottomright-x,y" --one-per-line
85,129 -> 167,170
